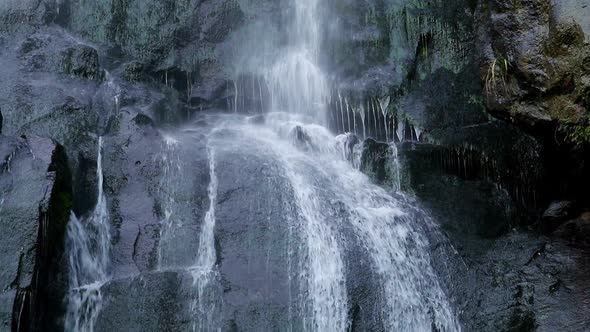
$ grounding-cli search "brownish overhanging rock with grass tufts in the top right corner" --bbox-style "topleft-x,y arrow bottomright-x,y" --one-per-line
477,0 -> 590,139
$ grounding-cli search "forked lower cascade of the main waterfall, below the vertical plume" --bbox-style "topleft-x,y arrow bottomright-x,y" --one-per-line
205,114 -> 461,331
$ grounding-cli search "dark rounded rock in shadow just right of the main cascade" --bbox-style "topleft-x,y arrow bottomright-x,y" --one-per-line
399,143 -> 518,240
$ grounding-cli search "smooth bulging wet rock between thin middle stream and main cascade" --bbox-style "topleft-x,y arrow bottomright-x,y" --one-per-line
215,142 -> 303,331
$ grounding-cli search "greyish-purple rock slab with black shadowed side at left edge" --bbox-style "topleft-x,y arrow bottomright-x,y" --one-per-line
0,136 -> 72,331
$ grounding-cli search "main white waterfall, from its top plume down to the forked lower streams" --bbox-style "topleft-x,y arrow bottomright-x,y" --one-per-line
227,0 -> 460,331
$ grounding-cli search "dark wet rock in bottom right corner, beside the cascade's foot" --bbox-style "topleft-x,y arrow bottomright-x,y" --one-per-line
454,231 -> 590,331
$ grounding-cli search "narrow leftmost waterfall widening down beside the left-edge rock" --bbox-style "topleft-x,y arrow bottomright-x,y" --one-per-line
65,137 -> 111,332
